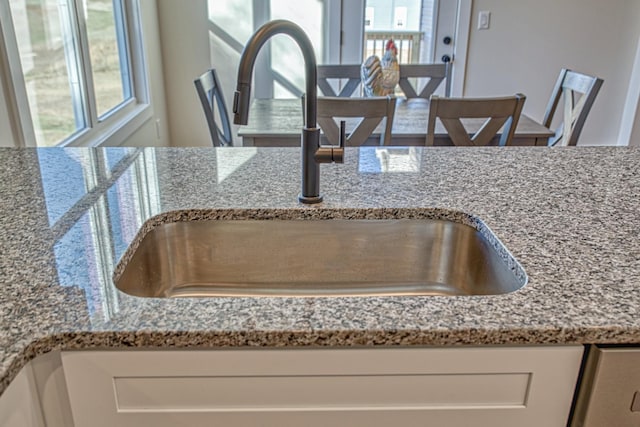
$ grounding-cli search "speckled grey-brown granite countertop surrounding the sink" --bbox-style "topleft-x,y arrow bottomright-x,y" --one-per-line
0,147 -> 640,392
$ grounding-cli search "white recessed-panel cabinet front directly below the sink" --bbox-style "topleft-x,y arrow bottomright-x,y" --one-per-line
62,346 -> 583,427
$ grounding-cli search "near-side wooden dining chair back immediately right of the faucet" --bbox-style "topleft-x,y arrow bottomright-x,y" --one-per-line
302,96 -> 396,146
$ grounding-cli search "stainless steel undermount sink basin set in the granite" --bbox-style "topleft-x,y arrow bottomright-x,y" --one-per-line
115,219 -> 527,297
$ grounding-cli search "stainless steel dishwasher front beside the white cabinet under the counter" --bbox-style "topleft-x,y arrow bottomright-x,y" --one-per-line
570,345 -> 640,427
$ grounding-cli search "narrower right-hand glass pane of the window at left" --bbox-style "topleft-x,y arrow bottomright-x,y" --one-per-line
84,0 -> 131,117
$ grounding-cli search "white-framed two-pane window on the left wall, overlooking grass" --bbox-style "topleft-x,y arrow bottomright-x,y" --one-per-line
0,0 -> 147,146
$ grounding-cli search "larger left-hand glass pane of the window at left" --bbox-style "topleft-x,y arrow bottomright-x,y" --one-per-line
9,0 -> 86,146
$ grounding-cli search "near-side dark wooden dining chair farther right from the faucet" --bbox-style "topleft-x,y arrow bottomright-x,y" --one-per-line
426,93 -> 526,146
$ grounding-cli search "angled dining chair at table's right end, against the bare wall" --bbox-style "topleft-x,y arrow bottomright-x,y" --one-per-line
542,68 -> 604,146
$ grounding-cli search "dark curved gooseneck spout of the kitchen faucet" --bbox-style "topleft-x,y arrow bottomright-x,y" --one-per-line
233,19 -> 318,129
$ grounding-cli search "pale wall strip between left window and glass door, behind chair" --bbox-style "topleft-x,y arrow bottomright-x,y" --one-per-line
157,0 -> 210,147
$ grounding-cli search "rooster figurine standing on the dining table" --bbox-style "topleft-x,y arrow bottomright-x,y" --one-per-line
360,40 -> 400,96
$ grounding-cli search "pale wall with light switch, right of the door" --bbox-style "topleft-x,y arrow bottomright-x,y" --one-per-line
464,0 -> 640,145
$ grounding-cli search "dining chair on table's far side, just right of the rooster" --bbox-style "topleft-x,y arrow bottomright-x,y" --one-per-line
398,62 -> 451,99
